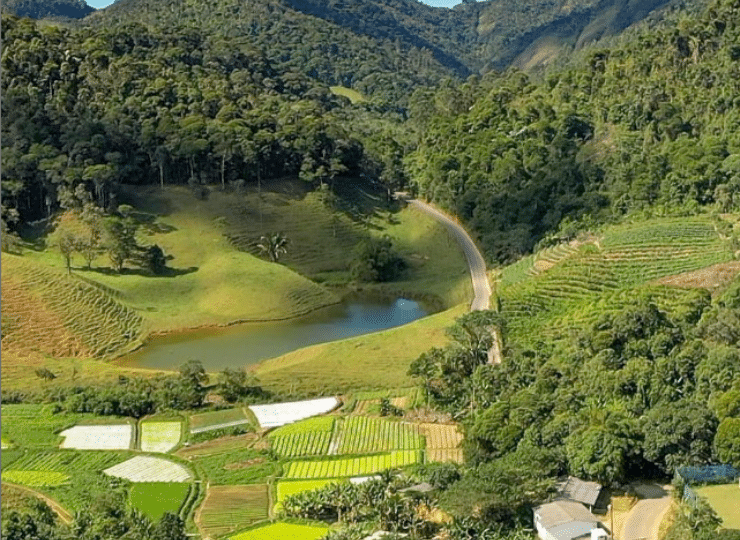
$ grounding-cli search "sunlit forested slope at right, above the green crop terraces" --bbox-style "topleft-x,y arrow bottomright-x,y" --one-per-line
407,1 -> 740,261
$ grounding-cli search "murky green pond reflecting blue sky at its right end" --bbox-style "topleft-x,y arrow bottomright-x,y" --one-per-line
116,295 -> 431,371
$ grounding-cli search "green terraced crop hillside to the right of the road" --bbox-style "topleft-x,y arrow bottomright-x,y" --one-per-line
499,217 -> 733,338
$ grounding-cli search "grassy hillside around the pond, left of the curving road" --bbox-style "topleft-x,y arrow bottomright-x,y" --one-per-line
2,180 -> 471,392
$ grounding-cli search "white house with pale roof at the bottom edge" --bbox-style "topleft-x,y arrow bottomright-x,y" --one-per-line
534,500 -> 609,540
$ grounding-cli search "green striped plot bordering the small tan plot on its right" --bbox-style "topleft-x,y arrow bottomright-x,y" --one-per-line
337,416 -> 424,454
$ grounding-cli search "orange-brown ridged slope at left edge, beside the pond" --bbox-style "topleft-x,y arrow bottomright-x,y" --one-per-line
2,253 -> 144,357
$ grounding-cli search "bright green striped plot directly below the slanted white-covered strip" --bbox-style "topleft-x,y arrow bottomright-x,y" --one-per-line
269,416 -> 334,457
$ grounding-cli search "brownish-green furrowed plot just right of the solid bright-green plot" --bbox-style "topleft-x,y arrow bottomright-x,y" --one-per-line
196,484 -> 269,538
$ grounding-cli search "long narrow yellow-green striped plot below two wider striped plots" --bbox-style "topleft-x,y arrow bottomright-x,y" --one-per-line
285,450 -> 421,478
